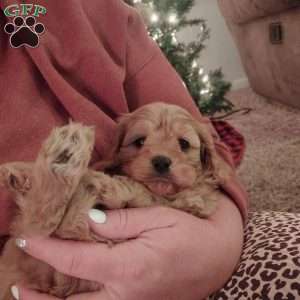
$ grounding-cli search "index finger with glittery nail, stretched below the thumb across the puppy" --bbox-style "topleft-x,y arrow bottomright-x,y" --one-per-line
16,237 -> 122,283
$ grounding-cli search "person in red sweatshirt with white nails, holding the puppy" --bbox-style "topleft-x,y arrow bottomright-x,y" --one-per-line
0,0 -> 247,300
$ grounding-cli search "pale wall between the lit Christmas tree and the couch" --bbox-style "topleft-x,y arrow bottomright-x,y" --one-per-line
183,0 -> 248,89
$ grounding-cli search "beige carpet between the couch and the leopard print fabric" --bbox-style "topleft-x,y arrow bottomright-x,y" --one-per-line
226,89 -> 300,212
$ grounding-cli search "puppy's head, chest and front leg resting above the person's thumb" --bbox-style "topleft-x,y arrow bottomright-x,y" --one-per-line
102,103 -> 232,217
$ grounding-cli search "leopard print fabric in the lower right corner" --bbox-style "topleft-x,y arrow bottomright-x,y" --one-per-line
207,212 -> 300,300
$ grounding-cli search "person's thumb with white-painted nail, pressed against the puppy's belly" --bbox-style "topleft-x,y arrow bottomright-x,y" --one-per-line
89,206 -> 182,240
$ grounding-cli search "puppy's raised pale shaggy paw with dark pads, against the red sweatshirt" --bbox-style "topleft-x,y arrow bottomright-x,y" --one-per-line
38,123 -> 95,176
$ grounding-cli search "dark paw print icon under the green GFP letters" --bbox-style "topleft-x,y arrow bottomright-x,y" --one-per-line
4,16 -> 45,48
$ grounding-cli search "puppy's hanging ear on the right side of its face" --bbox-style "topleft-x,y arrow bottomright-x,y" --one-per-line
195,122 -> 233,183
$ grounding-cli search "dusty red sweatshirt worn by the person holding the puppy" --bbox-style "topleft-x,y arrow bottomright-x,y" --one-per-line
0,0 -> 247,235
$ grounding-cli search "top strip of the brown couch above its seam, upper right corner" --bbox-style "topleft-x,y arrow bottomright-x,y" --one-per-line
218,0 -> 300,24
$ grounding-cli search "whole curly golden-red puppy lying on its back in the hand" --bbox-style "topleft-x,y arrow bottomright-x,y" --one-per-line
0,103 -> 232,300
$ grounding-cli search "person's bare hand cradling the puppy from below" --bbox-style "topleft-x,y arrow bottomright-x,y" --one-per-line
11,196 -> 243,300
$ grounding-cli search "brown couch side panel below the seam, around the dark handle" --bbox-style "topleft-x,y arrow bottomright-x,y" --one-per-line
229,7 -> 300,109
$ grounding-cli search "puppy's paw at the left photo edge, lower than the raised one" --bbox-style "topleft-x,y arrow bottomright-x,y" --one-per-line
0,162 -> 33,195
